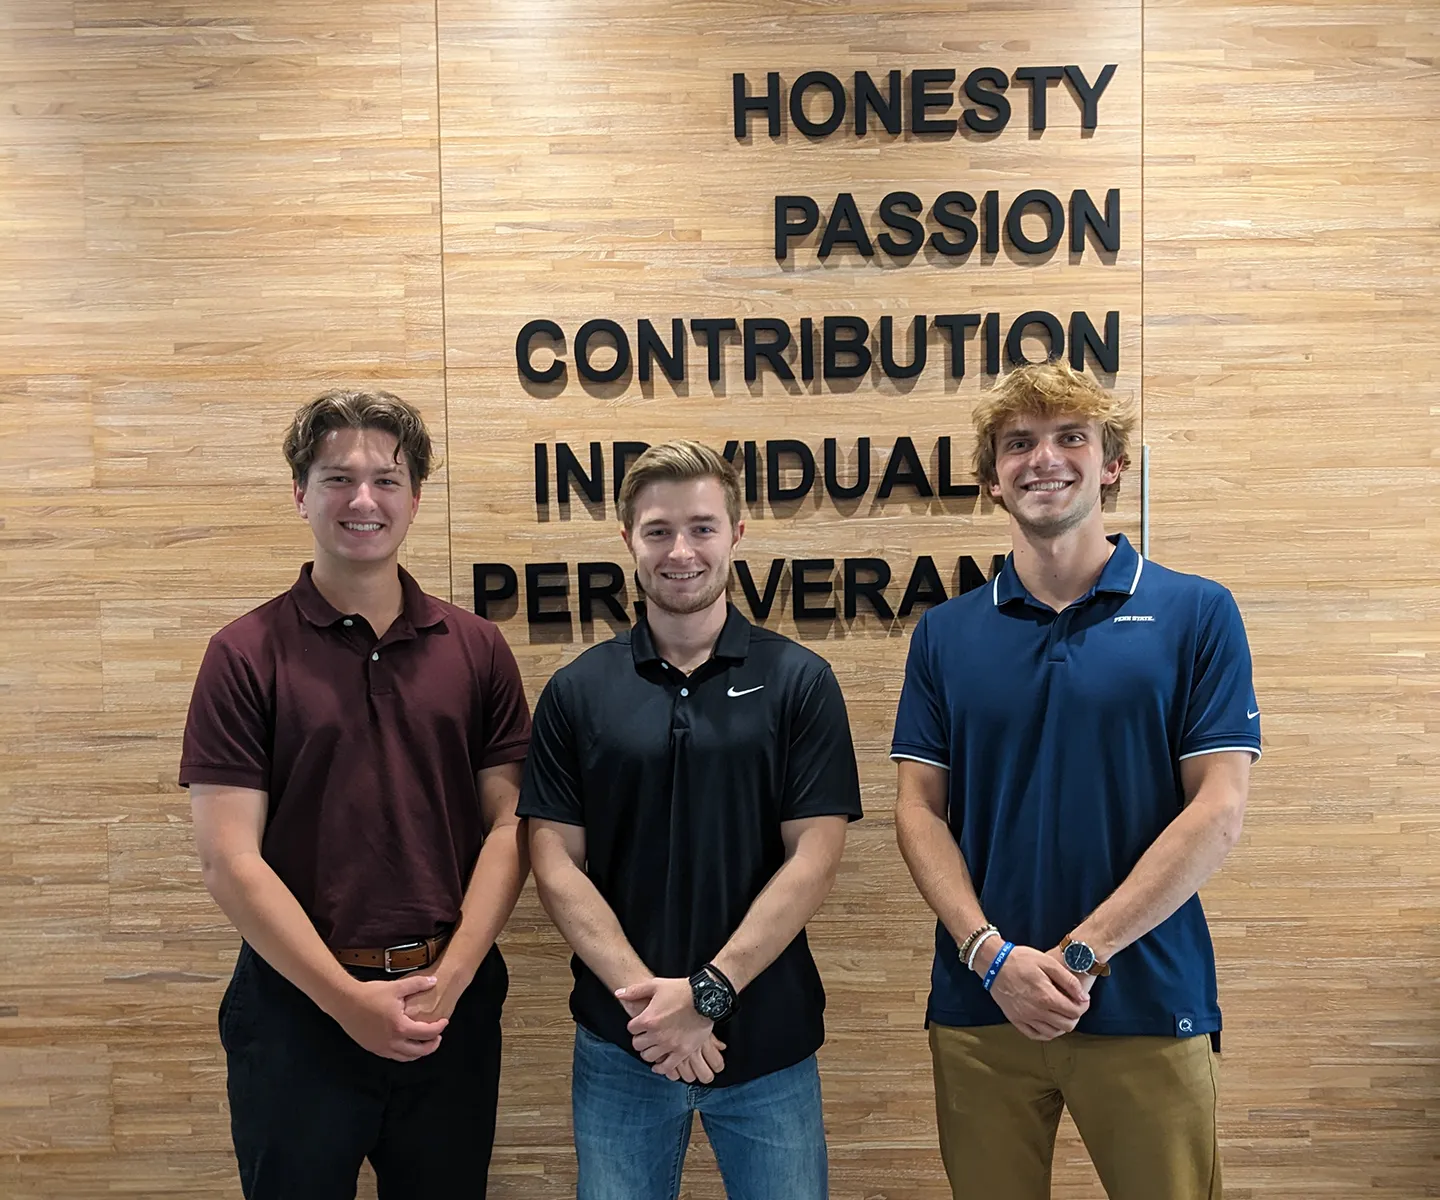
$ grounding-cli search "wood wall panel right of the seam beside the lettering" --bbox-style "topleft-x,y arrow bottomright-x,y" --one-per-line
1145,3 -> 1440,1200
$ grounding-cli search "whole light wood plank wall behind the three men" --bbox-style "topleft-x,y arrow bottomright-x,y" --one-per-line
0,0 -> 1440,1200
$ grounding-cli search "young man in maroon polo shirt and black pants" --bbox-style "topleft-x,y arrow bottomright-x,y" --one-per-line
180,390 -> 530,1200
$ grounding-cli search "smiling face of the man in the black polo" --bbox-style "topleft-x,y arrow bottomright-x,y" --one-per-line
622,477 -> 744,617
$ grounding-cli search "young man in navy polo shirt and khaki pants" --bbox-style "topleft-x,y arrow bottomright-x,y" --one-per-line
891,363 -> 1260,1200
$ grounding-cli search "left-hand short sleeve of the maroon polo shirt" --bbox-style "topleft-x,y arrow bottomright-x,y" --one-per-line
180,631 -> 274,791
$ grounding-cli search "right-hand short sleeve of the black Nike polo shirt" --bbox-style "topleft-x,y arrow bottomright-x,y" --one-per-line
780,666 -> 861,821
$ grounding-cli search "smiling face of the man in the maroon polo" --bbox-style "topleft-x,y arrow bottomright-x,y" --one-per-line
295,428 -> 420,569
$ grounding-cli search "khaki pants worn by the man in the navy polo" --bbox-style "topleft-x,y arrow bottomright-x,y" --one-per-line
930,1024 -> 1221,1200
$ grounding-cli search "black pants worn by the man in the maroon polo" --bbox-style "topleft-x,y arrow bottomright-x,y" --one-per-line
220,945 -> 508,1200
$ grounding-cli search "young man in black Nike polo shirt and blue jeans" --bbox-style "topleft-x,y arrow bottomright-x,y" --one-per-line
520,442 -> 860,1200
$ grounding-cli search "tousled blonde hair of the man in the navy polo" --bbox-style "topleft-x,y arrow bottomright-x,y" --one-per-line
971,359 -> 1135,507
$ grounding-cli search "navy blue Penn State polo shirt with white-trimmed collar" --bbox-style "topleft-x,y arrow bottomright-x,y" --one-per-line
891,534 -> 1260,1037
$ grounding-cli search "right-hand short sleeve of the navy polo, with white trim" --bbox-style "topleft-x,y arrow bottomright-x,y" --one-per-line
1179,588 -> 1260,758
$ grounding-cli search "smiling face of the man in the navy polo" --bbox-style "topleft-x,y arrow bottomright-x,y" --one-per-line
991,413 -> 1120,539
